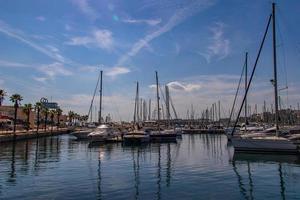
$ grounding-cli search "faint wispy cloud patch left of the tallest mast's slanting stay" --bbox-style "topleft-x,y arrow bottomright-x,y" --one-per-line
199,22 -> 230,63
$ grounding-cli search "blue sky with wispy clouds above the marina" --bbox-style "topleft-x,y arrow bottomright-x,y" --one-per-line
0,0 -> 300,121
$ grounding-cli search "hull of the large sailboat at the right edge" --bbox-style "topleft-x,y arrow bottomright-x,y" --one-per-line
231,137 -> 299,154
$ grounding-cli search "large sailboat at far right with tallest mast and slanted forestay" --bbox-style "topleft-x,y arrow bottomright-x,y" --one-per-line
231,3 -> 299,154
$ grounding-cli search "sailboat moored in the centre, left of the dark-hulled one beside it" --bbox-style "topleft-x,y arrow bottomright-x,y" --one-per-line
123,82 -> 150,144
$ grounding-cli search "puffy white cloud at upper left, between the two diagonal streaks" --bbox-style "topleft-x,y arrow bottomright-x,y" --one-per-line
66,29 -> 114,50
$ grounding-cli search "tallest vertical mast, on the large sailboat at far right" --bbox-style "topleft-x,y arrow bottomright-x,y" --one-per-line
272,3 -> 279,136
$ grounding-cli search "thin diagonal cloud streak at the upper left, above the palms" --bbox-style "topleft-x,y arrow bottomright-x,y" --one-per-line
0,20 -> 71,63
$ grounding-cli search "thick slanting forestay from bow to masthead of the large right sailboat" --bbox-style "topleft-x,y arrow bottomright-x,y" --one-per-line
231,14 -> 272,135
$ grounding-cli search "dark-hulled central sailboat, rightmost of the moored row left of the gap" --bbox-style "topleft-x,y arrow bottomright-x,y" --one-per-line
150,71 -> 177,142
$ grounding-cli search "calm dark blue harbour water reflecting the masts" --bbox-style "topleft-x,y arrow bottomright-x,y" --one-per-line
0,135 -> 300,199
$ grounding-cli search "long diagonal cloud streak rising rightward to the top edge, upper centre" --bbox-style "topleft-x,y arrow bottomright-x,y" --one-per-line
117,0 -> 214,65
